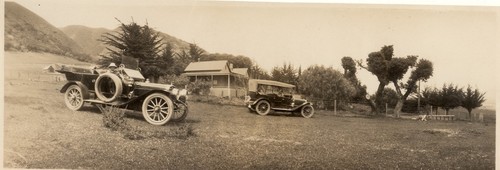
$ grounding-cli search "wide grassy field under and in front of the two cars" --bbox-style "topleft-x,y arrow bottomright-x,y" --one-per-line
3,51 -> 496,169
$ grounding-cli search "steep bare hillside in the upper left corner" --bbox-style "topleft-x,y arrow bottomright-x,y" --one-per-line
4,2 -> 88,60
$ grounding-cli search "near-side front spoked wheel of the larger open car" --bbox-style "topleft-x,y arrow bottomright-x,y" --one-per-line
142,93 -> 174,125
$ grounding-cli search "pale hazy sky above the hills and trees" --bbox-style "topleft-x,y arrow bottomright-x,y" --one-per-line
7,0 -> 500,106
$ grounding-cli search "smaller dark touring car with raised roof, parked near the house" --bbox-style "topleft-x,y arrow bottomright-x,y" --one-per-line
245,79 -> 314,118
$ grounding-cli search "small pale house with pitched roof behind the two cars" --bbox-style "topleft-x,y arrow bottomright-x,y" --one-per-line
183,60 -> 248,97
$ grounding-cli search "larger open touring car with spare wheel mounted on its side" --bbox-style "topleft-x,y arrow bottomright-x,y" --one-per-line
56,60 -> 188,125
